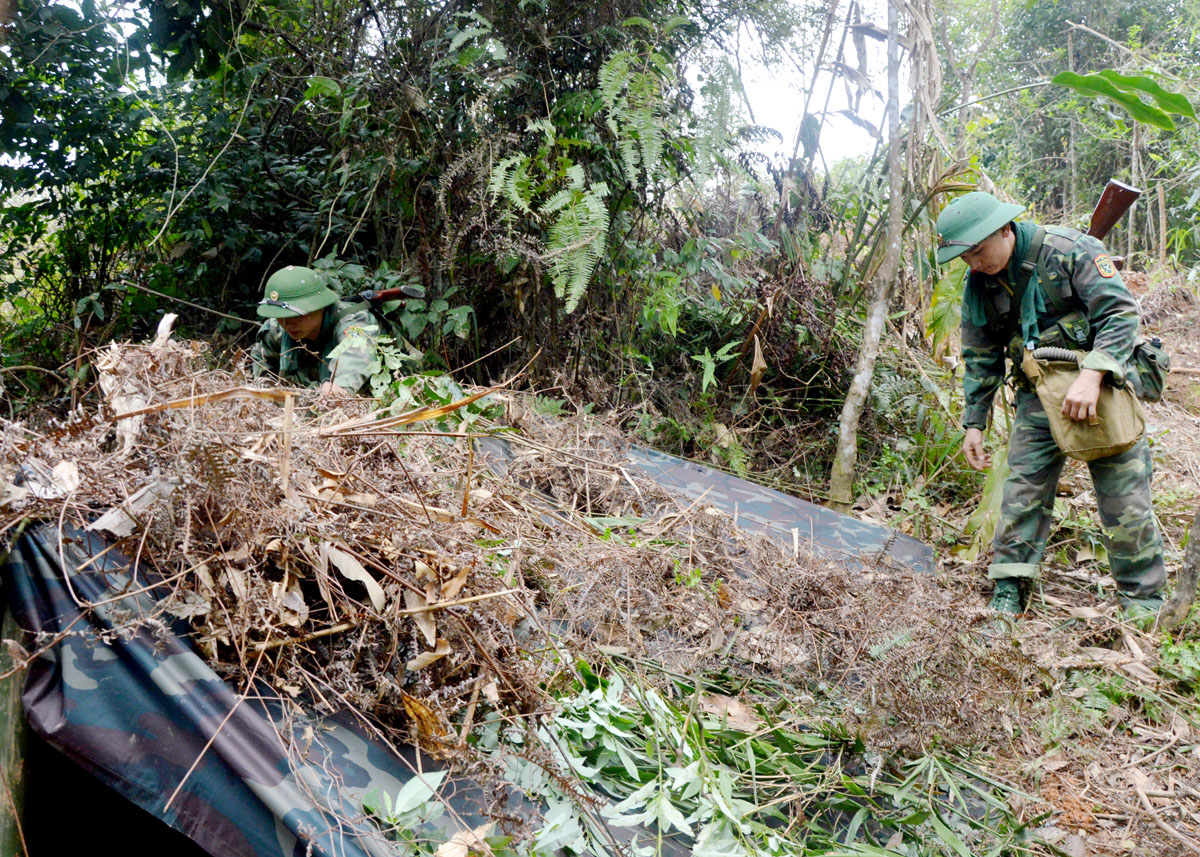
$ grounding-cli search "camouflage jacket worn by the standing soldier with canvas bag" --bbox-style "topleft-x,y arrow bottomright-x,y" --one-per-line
962,221 -> 1141,429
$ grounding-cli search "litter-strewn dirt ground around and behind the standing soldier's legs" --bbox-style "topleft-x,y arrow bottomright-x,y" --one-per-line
876,275 -> 1200,857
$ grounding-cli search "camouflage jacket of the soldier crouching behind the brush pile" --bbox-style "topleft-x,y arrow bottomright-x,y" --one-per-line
250,300 -> 380,392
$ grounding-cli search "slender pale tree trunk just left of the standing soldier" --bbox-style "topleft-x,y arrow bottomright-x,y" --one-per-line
829,0 -> 904,511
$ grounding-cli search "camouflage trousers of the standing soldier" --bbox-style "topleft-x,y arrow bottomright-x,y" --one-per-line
988,391 -> 1166,598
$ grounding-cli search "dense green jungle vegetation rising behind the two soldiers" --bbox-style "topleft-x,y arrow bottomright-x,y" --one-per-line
0,0 -> 1200,520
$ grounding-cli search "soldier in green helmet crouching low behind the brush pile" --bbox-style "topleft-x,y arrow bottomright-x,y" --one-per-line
250,265 -> 380,395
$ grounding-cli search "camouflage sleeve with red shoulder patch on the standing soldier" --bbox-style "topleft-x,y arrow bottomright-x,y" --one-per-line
1070,235 -> 1141,383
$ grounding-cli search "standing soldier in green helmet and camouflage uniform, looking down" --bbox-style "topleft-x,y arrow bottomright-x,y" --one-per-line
937,191 -> 1166,613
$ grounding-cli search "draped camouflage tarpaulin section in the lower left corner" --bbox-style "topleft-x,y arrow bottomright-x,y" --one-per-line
2,525 -> 482,857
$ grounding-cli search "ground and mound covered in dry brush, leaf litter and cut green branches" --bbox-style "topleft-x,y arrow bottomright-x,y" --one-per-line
0,277 -> 1200,857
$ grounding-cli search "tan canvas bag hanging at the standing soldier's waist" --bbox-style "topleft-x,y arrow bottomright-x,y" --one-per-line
1021,347 -> 1146,461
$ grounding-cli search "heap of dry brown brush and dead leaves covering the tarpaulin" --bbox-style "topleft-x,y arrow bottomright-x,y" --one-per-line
0,324 -> 1034,750
